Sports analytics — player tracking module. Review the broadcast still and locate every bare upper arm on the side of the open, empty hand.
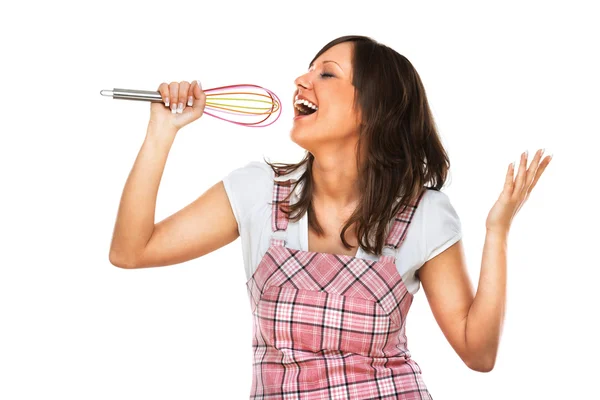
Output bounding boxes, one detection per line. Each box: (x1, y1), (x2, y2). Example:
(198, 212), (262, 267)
(417, 240), (475, 365)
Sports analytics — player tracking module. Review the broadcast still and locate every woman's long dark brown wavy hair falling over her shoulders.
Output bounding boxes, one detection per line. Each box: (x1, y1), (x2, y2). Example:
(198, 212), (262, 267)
(263, 35), (450, 254)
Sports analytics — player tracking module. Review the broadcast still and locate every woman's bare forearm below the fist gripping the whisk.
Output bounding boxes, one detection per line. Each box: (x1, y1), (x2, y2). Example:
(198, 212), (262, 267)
(110, 123), (176, 265)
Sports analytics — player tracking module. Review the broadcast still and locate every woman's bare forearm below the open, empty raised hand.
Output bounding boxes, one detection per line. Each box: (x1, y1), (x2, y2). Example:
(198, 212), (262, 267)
(465, 230), (508, 370)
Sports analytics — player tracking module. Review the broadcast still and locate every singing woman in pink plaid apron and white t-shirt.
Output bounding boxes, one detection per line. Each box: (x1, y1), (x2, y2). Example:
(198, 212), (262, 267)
(110, 36), (550, 399)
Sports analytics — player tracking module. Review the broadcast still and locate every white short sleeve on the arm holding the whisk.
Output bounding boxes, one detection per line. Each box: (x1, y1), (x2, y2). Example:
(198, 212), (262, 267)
(223, 161), (274, 234)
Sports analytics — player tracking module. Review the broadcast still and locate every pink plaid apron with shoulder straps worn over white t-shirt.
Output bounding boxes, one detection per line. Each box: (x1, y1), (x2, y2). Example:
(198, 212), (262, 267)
(246, 180), (432, 400)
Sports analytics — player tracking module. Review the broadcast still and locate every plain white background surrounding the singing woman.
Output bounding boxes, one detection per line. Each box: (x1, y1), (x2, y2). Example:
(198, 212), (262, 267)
(0, 0), (600, 400)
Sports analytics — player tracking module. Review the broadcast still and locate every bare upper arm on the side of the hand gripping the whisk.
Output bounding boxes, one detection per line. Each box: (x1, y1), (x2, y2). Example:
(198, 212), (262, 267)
(129, 181), (239, 268)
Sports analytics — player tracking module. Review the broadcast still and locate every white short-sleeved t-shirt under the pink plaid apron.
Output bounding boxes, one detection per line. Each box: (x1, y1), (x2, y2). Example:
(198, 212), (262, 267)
(223, 161), (462, 295)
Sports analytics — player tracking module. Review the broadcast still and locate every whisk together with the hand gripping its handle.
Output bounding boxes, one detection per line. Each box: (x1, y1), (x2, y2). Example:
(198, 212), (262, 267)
(100, 81), (281, 129)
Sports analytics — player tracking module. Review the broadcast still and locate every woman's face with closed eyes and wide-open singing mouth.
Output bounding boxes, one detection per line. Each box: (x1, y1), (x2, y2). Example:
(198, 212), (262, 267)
(290, 42), (360, 153)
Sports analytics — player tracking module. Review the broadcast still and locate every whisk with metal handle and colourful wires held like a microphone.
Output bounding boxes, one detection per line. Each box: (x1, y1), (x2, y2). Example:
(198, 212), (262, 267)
(100, 84), (281, 128)
